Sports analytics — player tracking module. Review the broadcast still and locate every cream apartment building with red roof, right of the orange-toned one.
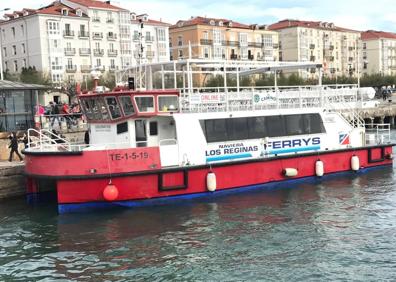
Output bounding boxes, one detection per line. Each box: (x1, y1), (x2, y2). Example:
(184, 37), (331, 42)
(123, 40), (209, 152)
(269, 19), (362, 77)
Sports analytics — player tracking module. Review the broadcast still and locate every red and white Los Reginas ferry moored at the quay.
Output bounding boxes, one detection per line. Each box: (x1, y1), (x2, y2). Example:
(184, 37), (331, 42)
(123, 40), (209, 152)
(24, 59), (393, 213)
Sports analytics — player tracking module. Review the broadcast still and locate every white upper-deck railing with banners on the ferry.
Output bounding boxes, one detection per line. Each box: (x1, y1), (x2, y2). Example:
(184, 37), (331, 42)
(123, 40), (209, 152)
(180, 85), (358, 113)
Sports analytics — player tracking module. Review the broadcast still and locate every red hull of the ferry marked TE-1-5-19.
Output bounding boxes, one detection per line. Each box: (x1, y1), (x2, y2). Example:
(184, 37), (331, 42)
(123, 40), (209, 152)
(26, 145), (392, 207)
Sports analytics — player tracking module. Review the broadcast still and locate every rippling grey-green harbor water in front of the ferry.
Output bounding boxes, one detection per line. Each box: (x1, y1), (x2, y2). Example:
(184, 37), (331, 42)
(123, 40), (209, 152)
(0, 136), (396, 281)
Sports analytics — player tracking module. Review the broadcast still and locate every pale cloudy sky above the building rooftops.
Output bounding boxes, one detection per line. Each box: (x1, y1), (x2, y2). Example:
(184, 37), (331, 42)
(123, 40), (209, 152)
(0, 0), (396, 32)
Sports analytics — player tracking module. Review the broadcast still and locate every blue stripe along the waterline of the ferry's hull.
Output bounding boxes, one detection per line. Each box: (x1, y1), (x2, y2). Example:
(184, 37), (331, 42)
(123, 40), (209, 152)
(58, 164), (392, 214)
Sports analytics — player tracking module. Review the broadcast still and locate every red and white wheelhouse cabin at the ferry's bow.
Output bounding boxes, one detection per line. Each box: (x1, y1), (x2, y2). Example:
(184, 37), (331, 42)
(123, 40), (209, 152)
(78, 90), (179, 149)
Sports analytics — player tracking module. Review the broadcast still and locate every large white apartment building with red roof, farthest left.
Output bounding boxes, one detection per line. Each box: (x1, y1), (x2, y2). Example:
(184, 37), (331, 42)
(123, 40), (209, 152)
(0, 0), (169, 84)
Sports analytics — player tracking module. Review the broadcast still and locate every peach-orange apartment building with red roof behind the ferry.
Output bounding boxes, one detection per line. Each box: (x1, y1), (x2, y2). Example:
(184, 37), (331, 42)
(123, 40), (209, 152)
(169, 17), (278, 61)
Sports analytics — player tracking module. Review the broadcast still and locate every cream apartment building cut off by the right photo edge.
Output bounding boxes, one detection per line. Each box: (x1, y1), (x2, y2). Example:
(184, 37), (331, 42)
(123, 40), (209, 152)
(362, 30), (396, 75)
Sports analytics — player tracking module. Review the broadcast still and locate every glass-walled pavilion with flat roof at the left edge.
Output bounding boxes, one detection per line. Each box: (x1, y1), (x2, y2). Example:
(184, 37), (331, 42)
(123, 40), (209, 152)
(0, 80), (49, 132)
